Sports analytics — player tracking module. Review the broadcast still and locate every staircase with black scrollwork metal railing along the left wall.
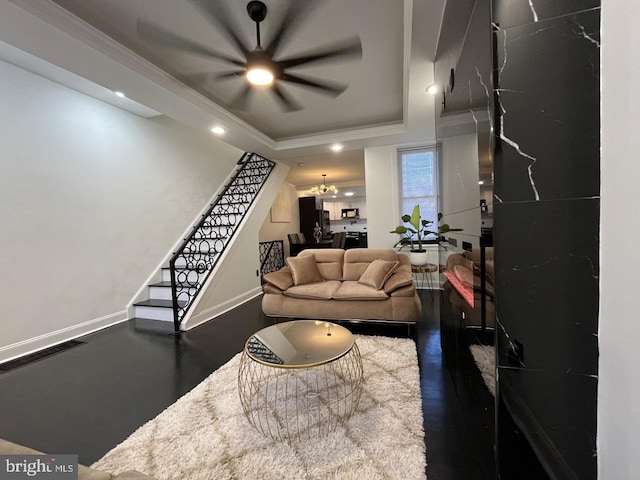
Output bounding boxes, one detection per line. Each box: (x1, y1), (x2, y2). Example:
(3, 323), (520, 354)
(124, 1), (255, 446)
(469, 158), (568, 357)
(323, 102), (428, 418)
(134, 153), (275, 332)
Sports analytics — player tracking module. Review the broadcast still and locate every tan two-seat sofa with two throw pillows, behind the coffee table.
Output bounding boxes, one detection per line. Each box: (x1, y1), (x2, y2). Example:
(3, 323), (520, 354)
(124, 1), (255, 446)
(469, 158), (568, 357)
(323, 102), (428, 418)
(262, 248), (421, 324)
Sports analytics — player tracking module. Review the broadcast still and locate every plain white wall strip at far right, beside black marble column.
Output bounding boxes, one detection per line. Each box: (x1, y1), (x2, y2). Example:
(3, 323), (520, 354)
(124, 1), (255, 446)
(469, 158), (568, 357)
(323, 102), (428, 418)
(598, 0), (640, 480)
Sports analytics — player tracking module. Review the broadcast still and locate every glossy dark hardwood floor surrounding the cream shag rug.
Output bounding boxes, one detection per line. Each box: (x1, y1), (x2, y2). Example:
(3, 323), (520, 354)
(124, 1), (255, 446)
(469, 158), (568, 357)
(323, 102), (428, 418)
(0, 291), (483, 480)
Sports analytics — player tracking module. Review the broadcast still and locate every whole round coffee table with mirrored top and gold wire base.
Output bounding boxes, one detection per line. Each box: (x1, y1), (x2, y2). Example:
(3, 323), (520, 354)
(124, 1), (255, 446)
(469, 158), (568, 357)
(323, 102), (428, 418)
(238, 320), (362, 440)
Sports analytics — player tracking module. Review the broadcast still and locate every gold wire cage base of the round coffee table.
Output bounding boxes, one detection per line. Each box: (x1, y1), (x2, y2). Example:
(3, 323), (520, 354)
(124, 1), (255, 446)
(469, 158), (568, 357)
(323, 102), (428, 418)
(238, 342), (363, 441)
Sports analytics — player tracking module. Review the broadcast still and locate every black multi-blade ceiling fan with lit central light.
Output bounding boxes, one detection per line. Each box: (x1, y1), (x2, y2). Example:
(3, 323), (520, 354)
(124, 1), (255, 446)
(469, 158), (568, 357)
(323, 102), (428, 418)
(137, 0), (362, 111)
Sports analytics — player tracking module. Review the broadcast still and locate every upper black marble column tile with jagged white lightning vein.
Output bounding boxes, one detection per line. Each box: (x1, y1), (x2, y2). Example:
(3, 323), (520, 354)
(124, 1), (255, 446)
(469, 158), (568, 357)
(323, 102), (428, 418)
(495, 10), (600, 202)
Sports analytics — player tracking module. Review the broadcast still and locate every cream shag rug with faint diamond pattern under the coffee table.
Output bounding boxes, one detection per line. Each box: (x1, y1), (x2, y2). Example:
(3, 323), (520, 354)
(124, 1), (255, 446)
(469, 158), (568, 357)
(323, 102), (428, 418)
(92, 335), (426, 480)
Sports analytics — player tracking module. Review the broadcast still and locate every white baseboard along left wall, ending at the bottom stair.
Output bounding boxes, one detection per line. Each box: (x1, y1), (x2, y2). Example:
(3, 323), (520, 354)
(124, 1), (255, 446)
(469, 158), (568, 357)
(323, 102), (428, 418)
(0, 310), (127, 363)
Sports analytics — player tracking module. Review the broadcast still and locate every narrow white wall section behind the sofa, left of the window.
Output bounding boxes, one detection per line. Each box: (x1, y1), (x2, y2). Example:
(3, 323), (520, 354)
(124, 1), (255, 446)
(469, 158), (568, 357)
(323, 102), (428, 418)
(364, 145), (400, 248)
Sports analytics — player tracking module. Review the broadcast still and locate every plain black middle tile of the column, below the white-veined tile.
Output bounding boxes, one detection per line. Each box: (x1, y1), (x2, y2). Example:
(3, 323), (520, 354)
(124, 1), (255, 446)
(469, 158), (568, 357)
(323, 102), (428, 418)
(494, 199), (600, 374)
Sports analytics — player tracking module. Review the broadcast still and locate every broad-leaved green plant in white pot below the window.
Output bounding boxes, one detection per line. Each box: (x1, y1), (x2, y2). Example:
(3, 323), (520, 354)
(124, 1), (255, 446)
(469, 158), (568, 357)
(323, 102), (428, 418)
(390, 205), (462, 265)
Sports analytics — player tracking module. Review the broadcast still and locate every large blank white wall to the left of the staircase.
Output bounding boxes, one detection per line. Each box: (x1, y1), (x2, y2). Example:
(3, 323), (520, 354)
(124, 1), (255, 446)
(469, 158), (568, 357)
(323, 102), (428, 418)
(0, 62), (242, 360)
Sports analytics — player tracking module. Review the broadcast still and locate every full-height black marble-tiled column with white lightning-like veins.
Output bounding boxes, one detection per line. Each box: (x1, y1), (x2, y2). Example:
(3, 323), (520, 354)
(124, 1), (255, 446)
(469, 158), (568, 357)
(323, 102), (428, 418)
(493, 0), (600, 479)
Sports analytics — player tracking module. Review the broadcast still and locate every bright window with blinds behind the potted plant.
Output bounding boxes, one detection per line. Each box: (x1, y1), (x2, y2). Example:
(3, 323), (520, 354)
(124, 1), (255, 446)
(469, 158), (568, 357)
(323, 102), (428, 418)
(398, 143), (438, 239)
